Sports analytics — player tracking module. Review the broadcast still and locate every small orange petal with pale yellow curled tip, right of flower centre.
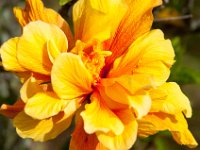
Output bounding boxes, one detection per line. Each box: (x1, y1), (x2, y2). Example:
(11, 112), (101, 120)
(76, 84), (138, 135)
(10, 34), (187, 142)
(101, 76), (151, 118)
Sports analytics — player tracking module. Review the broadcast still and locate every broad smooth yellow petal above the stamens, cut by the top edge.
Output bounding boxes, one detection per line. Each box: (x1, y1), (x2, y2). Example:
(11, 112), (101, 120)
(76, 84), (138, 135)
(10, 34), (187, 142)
(73, 0), (127, 43)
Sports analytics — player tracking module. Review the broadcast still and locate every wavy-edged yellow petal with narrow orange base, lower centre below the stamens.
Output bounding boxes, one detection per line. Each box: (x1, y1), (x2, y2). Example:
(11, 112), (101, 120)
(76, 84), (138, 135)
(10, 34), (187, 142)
(81, 93), (124, 135)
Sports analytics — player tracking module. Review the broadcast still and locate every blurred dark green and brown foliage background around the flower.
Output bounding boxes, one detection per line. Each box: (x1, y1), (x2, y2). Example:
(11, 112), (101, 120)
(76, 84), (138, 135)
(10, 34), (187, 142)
(0, 0), (200, 150)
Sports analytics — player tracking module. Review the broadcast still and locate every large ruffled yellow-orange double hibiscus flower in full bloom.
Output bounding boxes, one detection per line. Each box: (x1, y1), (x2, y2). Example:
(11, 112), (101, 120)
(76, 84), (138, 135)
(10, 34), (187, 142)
(0, 0), (197, 150)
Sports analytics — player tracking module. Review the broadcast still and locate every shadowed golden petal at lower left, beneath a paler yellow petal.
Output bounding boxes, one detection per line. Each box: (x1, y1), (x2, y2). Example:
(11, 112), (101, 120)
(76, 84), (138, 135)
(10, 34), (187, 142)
(14, 111), (72, 142)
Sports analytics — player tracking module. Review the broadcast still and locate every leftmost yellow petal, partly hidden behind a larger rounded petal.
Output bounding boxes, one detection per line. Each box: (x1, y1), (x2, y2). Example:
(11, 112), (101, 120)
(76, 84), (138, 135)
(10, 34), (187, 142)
(0, 37), (26, 72)
